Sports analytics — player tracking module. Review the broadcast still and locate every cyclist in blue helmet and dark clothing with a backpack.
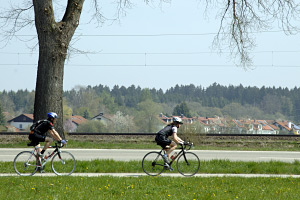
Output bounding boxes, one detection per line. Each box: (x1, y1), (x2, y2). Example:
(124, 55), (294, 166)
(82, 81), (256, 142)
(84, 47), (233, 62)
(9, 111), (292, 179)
(28, 112), (66, 159)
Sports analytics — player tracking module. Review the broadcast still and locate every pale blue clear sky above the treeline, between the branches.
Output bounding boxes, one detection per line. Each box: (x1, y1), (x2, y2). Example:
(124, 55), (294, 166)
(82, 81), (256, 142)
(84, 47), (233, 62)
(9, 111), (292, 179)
(0, 0), (300, 91)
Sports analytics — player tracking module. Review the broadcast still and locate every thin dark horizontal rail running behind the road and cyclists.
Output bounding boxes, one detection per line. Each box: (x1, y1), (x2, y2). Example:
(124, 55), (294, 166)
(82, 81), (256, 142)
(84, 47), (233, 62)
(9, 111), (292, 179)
(0, 132), (300, 137)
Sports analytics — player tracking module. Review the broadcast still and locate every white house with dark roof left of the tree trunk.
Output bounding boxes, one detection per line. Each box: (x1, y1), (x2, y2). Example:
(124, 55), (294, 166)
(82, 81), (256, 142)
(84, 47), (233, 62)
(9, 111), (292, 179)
(7, 114), (33, 131)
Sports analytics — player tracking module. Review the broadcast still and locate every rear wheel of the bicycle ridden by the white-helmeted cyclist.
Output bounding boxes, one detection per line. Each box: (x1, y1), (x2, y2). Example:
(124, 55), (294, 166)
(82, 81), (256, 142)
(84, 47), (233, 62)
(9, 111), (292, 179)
(142, 151), (165, 176)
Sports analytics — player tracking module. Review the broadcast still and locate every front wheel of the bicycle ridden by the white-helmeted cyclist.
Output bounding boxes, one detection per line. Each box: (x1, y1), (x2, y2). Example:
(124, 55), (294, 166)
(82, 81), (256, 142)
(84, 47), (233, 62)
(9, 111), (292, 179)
(177, 152), (200, 176)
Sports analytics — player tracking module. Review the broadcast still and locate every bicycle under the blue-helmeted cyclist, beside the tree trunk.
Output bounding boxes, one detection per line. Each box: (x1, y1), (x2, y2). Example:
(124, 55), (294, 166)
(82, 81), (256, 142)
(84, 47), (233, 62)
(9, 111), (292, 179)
(14, 143), (76, 176)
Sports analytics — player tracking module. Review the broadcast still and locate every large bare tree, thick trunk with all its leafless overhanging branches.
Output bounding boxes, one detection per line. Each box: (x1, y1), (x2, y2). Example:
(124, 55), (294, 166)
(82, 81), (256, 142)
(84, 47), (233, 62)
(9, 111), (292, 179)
(0, 0), (300, 136)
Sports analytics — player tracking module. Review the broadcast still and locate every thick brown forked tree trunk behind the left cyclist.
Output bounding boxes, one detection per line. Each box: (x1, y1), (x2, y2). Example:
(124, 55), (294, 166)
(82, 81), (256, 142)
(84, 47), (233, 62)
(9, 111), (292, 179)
(33, 0), (84, 138)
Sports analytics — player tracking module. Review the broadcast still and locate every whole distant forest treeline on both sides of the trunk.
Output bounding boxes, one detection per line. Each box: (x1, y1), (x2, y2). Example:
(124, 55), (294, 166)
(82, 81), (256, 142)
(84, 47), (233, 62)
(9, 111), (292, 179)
(0, 83), (300, 123)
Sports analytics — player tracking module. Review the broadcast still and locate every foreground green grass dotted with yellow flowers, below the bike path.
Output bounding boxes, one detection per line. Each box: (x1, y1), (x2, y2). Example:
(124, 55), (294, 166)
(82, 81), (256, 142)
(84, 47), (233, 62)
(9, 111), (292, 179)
(0, 176), (300, 200)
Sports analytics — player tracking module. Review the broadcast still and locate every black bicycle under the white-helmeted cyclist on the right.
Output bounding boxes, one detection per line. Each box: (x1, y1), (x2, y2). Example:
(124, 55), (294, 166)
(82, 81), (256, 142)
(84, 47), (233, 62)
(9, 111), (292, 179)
(142, 143), (200, 176)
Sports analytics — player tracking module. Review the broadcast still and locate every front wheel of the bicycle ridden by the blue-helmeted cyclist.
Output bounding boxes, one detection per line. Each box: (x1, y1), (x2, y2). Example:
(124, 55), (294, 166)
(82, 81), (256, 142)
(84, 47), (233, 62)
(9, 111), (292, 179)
(51, 151), (76, 176)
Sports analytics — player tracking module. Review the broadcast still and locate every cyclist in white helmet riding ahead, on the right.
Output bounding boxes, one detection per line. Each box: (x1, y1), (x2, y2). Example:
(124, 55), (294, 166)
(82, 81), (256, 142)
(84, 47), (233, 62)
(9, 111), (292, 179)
(155, 117), (184, 168)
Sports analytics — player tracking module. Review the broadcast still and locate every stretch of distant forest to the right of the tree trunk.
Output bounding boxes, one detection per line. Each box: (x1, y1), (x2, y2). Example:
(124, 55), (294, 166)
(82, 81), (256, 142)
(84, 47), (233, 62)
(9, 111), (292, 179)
(64, 83), (300, 121)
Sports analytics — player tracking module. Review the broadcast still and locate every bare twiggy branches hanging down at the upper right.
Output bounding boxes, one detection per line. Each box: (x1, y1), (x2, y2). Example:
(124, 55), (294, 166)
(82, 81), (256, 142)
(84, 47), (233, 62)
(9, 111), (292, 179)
(210, 0), (300, 69)
